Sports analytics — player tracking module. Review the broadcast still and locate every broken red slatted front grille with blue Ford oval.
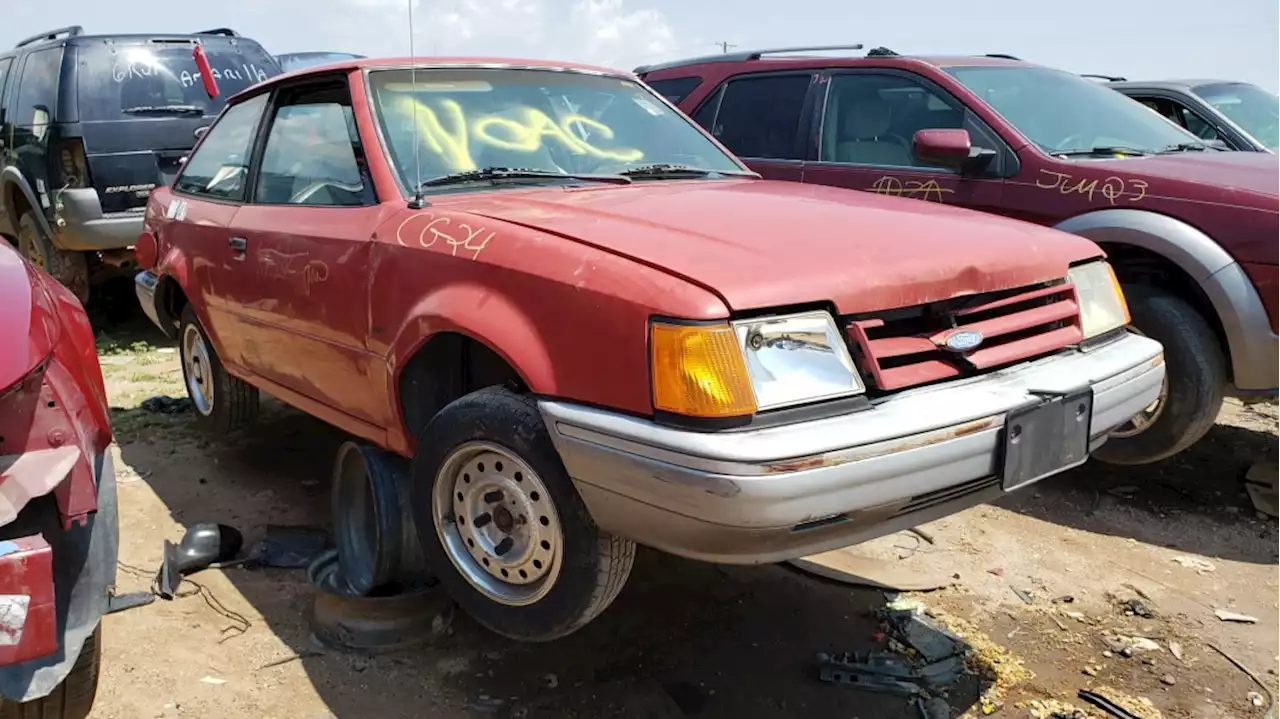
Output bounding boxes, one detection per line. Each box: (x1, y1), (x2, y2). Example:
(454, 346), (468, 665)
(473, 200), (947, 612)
(846, 281), (1084, 391)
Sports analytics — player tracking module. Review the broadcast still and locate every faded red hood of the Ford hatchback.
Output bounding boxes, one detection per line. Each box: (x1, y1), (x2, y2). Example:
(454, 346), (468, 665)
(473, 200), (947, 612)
(466, 180), (1102, 313)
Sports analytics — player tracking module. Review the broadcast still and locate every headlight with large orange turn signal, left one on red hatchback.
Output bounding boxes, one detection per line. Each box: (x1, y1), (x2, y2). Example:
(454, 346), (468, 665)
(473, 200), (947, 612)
(652, 312), (865, 417)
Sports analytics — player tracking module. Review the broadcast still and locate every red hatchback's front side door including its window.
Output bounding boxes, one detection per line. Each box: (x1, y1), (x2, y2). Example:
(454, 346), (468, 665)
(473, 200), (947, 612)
(229, 75), (389, 423)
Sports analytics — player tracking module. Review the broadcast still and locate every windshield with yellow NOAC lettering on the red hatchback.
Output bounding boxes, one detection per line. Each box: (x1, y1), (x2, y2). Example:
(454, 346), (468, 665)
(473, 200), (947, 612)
(369, 68), (746, 192)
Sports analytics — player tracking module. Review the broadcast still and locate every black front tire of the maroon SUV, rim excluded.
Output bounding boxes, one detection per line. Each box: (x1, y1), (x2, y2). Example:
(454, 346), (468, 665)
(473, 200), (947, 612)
(1094, 285), (1226, 464)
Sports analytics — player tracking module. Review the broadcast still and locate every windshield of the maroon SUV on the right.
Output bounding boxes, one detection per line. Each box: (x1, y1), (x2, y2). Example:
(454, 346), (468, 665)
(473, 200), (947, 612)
(947, 65), (1202, 154)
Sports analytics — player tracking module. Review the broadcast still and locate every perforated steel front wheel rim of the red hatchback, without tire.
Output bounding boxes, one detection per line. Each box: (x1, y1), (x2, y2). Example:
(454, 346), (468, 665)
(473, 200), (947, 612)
(431, 441), (564, 606)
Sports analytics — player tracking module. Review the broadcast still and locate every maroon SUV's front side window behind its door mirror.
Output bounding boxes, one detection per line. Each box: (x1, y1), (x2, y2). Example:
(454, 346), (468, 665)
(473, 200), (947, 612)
(819, 74), (962, 169)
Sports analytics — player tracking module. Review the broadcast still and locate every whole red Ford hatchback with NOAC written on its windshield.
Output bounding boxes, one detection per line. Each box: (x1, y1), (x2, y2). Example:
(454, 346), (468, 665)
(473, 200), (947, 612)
(137, 59), (1164, 640)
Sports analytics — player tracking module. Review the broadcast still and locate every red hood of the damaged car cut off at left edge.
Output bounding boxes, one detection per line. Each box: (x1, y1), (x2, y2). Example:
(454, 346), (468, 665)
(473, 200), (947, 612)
(0, 243), (58, 393)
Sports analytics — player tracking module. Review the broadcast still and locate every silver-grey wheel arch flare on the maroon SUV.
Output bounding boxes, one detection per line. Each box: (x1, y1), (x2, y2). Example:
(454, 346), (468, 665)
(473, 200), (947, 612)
(1055, 209), (1280, 391)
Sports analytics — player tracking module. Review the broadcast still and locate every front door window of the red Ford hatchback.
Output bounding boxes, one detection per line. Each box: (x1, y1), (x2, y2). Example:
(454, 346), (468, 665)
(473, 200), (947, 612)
(253, 81), (371, 207)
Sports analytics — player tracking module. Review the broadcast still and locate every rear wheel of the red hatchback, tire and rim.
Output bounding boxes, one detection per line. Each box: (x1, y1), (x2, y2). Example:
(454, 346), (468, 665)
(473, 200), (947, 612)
(178, 304), (259, 434)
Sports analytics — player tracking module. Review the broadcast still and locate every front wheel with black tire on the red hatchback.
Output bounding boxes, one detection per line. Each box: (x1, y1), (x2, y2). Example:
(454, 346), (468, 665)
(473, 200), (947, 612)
(413, 388), (635, 641)
